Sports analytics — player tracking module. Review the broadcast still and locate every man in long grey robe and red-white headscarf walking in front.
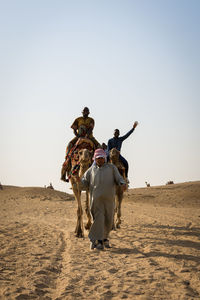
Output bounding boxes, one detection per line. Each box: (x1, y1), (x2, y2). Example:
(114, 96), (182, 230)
(81, 149), (126, 250)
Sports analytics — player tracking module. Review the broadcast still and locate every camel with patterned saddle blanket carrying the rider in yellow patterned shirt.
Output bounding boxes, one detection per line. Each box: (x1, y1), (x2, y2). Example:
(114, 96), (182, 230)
(69, 138), (94, 238)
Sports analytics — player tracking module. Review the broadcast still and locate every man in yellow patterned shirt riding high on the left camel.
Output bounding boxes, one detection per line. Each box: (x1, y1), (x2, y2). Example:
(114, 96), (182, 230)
(61, 107), (100, 182)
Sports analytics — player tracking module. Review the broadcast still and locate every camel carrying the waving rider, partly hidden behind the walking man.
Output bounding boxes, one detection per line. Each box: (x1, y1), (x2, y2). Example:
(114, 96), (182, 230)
(109, 148), (128, 229)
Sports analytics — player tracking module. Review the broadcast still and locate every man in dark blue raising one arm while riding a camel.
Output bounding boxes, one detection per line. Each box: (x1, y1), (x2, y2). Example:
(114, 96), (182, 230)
(108, 121), (138, 181)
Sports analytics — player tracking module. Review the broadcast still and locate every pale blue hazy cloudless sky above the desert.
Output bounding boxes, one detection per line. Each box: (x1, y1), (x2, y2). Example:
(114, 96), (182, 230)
(0, 0), (200, 193)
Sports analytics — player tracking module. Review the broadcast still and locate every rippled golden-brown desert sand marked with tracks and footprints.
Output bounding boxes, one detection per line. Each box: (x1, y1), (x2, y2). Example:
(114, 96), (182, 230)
(0, 181), (200, 300)
